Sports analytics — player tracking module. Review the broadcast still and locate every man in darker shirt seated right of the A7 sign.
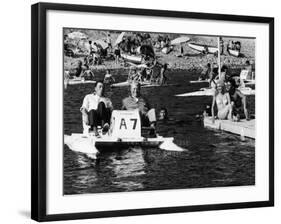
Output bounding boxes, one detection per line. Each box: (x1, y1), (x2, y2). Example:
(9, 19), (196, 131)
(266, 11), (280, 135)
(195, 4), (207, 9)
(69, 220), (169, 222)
(122, 82), (156, 137)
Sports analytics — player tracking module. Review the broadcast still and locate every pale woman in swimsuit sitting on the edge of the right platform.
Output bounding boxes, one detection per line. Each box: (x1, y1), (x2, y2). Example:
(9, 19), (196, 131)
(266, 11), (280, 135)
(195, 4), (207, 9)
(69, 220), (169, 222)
(211, 82), (232, 123)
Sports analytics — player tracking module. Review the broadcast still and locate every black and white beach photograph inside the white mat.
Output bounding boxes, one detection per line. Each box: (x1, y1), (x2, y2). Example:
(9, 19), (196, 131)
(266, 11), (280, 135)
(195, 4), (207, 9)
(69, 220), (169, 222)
(62, 27), (256, 195)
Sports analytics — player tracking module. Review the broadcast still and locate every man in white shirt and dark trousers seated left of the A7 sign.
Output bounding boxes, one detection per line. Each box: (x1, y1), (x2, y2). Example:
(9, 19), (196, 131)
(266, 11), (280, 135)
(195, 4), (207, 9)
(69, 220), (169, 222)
(80, 81), (113, 137)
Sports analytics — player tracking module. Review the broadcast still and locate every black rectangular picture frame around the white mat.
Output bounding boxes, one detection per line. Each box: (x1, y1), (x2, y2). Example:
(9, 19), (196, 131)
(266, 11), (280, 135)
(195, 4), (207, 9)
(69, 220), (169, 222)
(31, 3), (274, 221)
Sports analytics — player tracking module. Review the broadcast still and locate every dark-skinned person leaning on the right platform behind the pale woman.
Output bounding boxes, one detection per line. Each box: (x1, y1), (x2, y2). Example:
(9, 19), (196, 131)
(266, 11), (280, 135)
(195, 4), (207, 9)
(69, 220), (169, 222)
(225, 79), (249, 121)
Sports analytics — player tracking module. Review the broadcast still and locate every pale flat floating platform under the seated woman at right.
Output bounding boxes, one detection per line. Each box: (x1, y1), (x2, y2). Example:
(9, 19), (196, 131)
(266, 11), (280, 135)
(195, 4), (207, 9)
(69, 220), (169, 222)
(204, 117), (256, 139)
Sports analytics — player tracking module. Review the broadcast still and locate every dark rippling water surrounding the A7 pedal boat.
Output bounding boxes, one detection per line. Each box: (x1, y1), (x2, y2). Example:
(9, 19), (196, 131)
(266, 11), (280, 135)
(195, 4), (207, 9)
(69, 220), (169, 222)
(64, 70), (255, 194)
